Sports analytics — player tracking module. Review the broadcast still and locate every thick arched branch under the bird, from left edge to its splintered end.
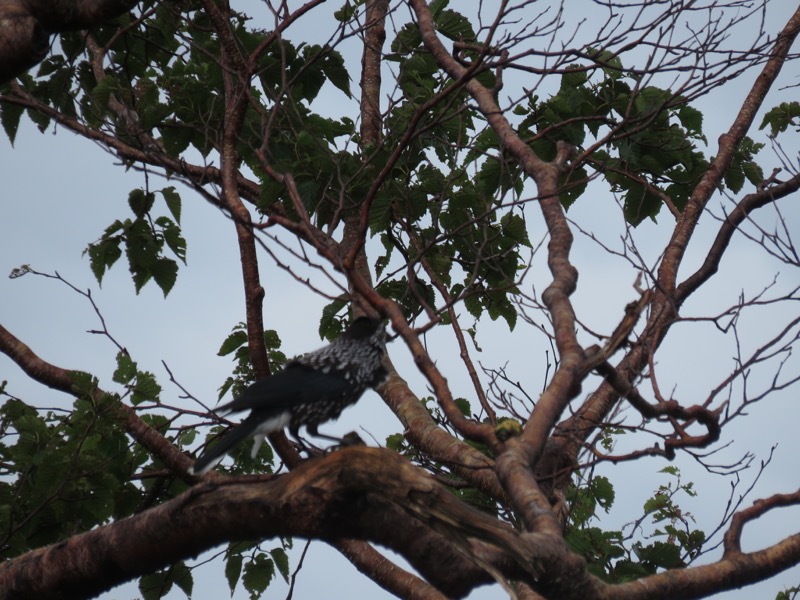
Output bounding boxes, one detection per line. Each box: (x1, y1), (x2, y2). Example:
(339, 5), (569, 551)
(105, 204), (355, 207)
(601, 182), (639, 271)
(0, 447), (531, 599)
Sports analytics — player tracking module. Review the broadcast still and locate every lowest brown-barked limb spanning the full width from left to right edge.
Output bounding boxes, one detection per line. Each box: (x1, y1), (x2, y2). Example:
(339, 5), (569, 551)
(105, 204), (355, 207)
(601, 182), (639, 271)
(0, 447), (800, 600)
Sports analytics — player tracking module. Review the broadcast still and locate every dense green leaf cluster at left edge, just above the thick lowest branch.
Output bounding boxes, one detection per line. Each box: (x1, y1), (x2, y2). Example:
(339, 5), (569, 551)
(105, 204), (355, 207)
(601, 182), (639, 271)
(0, 392), (141, 558)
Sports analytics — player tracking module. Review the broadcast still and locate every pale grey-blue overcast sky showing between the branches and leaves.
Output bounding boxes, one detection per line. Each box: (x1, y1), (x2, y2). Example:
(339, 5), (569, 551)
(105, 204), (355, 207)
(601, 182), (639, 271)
(0, 2), (800, 600)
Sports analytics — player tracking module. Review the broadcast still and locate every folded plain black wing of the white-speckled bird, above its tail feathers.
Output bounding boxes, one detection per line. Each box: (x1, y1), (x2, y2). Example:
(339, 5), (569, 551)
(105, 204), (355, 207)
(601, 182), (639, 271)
(215, 363), (351, 413)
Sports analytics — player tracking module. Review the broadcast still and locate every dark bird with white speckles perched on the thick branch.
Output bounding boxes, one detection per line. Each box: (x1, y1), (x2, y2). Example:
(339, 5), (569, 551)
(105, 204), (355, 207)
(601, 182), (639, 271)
(189, 316), (389, 475)
